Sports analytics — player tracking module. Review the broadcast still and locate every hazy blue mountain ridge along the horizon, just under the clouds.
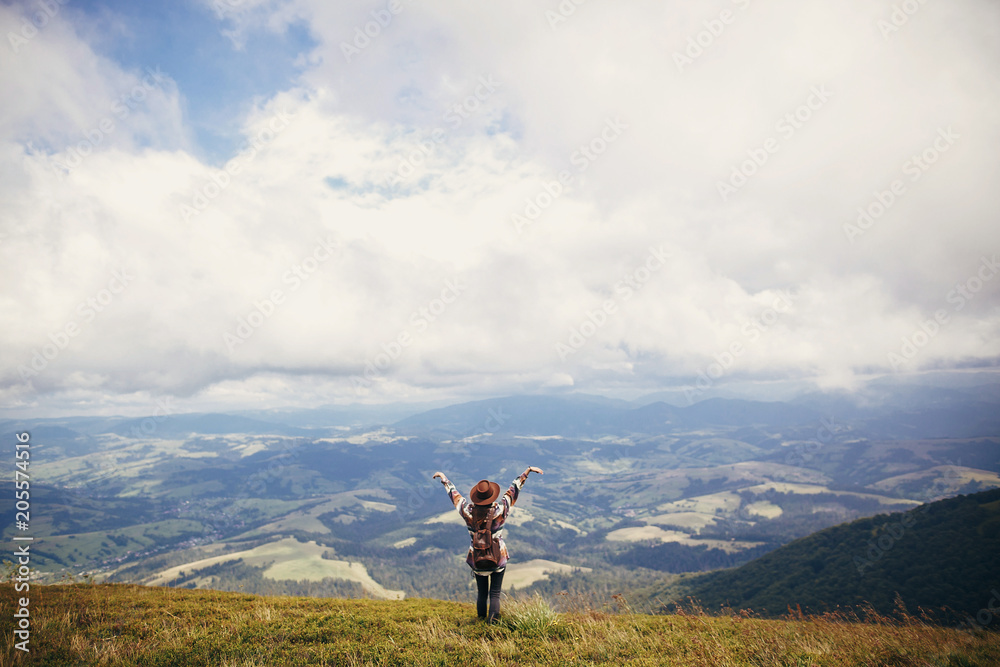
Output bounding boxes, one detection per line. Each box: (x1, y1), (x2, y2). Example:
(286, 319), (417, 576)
(7, 382), (1000, 440)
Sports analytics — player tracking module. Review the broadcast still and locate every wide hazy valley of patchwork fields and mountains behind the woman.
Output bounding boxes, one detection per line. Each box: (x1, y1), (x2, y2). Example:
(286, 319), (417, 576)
(0, 382), (1000, 624)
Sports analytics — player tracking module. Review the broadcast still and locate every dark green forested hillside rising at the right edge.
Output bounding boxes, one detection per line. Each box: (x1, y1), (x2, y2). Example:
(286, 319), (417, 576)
(672, 489), (1000, 624)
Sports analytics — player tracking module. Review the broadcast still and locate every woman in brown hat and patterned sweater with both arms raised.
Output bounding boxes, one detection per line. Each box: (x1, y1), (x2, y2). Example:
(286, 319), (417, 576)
(433, 466), (543, 624)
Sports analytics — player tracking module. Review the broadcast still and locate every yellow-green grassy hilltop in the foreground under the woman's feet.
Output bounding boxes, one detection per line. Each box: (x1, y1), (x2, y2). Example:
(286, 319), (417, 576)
(0, 584), (1000, 667)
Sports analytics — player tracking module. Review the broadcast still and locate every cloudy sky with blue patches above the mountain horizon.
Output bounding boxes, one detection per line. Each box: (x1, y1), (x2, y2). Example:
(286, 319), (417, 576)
(0, 0), (1000, 416)
